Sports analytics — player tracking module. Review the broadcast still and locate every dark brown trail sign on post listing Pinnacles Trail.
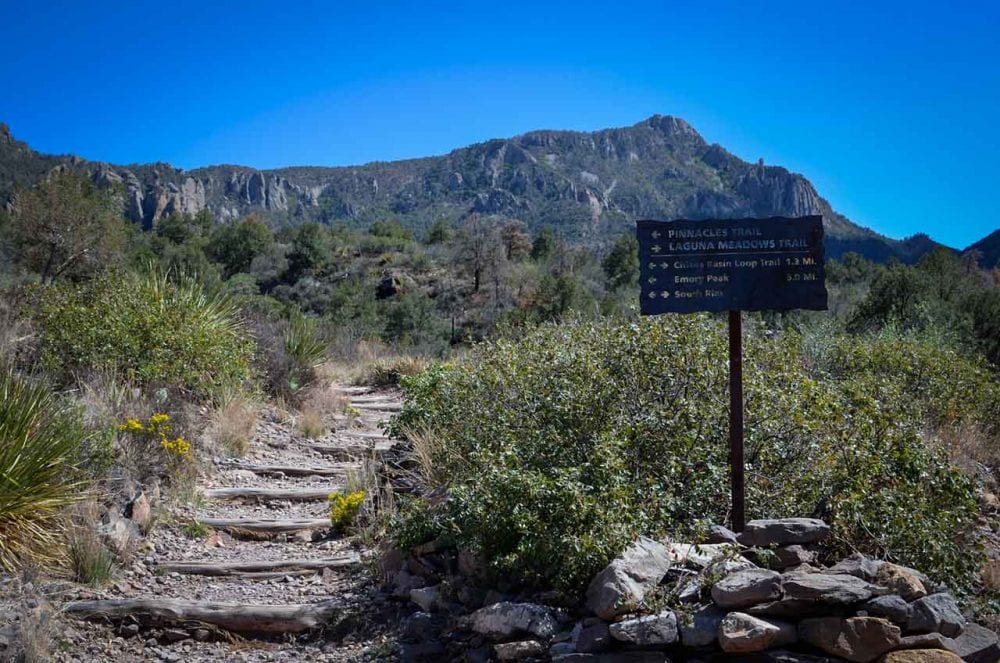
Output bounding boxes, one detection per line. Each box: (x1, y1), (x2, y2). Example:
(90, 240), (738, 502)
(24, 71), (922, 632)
(636, 216), (827, 531)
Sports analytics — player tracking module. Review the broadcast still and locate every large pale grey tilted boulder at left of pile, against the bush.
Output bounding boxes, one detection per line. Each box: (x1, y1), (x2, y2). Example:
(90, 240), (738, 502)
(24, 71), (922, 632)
(587, 537), (672, 619)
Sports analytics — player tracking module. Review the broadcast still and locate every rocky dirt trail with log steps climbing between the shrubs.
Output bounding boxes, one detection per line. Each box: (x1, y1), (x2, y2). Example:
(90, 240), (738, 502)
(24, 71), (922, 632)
(56, 386), (401, 663)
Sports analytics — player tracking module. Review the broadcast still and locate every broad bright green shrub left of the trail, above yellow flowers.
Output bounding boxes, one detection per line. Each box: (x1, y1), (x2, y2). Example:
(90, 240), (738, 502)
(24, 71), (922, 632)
(37, 272), (253, 398)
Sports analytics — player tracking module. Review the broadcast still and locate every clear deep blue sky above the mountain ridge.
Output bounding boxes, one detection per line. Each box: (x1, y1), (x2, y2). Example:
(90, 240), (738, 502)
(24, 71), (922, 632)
(0, 0), (1000, 247)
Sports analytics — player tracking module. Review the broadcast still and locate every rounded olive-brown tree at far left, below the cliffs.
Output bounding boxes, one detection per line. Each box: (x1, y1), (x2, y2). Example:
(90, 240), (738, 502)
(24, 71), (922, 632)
(10, 170), (127, 283)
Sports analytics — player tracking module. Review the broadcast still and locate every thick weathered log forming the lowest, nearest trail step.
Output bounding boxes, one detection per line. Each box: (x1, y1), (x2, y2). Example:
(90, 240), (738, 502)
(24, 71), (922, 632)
(62, 599), (341, 635)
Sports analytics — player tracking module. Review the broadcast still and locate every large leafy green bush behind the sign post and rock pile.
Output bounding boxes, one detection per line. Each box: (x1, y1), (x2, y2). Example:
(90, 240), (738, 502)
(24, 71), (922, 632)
(393, 316), (985, 590)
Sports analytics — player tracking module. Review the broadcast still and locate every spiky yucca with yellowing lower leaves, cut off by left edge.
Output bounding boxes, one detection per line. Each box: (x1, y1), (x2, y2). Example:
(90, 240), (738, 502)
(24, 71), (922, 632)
(0, 368), (84, 571)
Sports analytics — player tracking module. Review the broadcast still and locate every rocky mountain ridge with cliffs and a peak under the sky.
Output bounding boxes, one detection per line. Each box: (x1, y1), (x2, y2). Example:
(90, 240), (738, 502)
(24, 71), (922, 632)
(0, 115), (939, 262)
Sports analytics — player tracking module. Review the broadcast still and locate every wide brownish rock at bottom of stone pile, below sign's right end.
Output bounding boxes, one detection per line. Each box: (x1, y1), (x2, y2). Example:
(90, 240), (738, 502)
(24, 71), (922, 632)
(799, 617), (900, 663)
